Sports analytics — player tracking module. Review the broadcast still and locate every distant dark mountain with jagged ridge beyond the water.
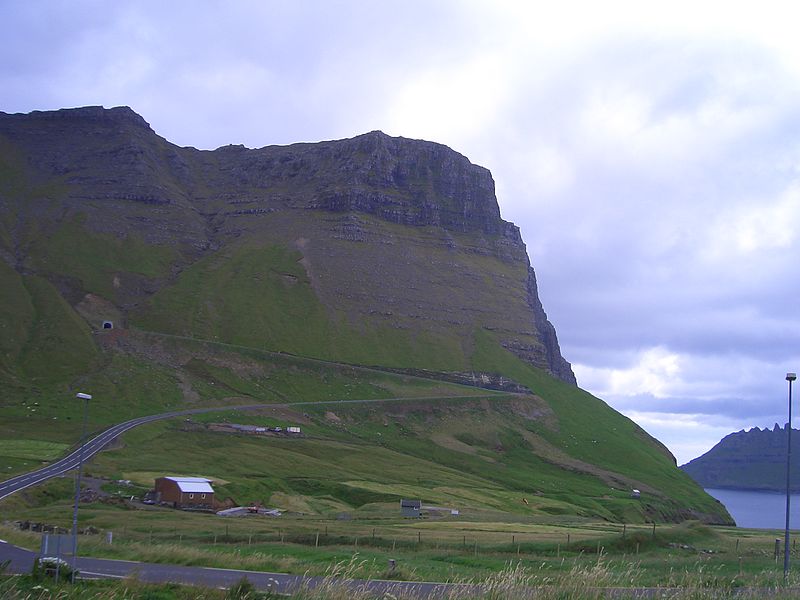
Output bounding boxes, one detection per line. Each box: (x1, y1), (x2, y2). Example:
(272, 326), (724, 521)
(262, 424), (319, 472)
(681, 423), (800, 492)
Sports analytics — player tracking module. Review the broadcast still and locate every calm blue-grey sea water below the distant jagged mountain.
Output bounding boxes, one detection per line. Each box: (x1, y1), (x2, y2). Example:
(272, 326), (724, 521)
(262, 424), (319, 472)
(706, 488), (800, 531)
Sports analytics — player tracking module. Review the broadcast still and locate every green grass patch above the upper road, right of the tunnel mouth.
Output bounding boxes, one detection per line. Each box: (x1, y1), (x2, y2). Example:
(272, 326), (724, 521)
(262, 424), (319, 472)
(132, 238), (476, 370)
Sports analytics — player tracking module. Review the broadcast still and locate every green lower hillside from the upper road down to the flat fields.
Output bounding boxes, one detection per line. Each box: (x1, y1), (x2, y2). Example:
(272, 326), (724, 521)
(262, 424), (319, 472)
(0, 332), (721, 523)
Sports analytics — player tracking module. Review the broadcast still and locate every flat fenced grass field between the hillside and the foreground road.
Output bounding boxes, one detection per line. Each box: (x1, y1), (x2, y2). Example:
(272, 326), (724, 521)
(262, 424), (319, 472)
(0, 505), (800, 598)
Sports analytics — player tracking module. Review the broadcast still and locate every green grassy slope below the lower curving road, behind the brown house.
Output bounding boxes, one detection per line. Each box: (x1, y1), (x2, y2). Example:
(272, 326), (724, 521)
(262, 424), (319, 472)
(70, 384), (717, 523)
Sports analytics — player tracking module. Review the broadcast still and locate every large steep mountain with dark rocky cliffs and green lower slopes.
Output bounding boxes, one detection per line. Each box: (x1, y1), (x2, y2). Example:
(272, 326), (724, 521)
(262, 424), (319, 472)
(0, 107), (731, 523)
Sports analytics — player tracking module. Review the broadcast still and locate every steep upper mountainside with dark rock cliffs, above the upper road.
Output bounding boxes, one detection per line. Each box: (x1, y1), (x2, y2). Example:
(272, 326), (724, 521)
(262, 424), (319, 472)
(0, 107), (575, 384)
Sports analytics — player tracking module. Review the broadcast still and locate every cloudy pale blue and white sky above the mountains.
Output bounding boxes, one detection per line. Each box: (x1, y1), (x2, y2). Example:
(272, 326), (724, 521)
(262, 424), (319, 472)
(0, 0), (800, 464)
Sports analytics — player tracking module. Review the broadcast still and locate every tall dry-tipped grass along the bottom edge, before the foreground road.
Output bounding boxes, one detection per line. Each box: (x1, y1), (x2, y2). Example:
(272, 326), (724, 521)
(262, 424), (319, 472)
(0, 555), (800, 600)
